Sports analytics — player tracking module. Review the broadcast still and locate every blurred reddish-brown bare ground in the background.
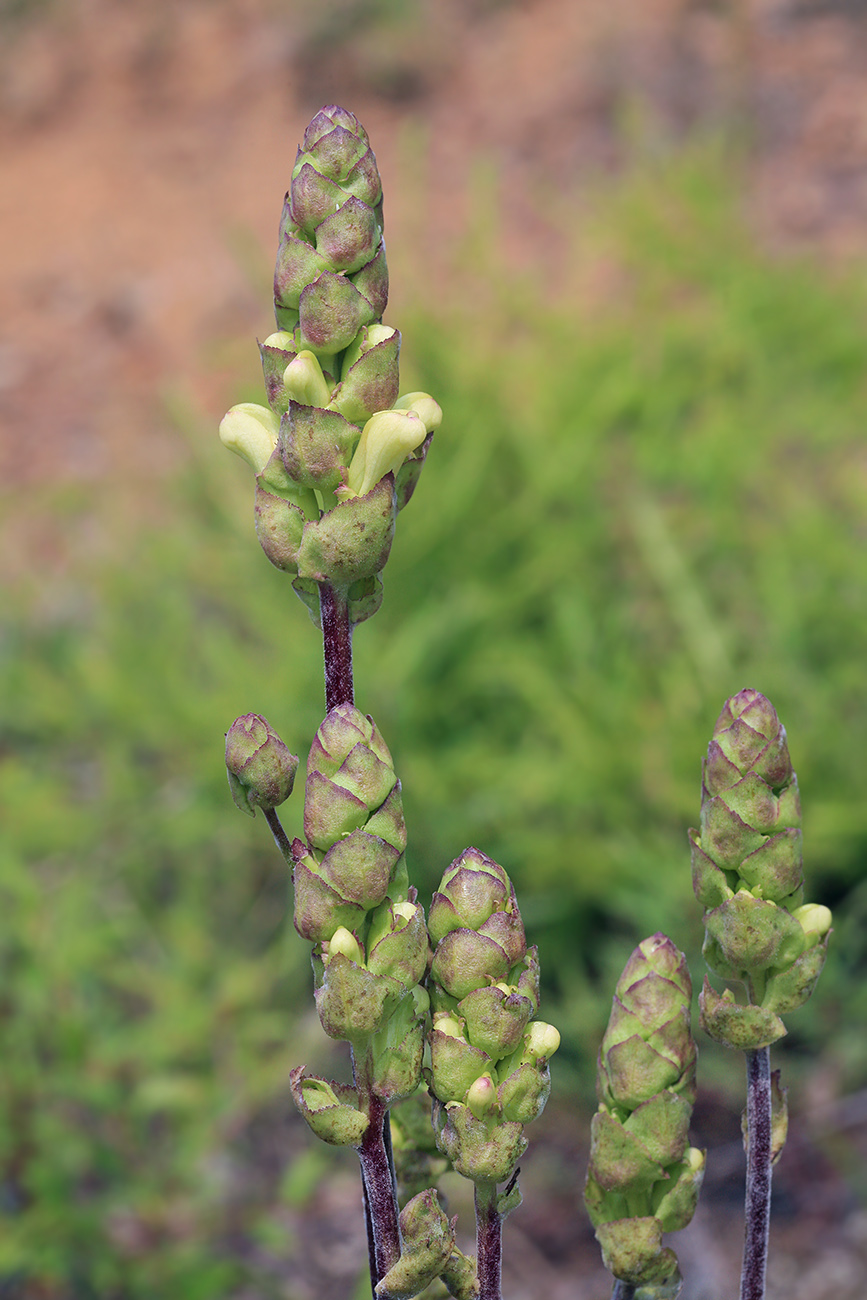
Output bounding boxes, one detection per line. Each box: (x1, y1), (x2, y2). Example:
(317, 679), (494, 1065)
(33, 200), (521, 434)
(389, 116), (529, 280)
(0, 0), (867, 1300)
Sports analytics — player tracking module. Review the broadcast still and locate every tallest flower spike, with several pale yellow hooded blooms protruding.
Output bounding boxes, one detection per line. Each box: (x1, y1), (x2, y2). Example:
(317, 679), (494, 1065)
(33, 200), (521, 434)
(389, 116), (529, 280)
(220, 105), (441, 623)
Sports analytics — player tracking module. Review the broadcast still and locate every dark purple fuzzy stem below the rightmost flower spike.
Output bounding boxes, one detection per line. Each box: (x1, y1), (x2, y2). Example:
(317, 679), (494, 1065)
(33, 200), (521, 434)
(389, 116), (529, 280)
(741, 1048), (771, 1300)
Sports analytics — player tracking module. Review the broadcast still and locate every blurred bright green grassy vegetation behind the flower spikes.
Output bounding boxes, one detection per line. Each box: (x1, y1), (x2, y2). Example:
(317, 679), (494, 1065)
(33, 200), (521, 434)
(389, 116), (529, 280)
(0, 144), (867, 1300)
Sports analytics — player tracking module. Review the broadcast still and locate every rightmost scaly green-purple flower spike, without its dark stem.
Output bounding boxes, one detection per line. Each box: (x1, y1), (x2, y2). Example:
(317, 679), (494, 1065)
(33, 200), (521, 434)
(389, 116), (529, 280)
(690, 689), (831, 1050)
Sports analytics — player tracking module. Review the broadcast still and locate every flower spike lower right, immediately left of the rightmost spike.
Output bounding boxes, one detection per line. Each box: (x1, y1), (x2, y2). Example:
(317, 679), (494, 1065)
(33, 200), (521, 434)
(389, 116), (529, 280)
(585, 933), (705, 1295)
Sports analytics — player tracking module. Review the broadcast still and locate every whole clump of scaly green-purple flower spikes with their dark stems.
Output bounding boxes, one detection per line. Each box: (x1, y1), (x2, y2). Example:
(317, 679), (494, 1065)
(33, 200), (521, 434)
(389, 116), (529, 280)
(220, 105), (831, 1300)
